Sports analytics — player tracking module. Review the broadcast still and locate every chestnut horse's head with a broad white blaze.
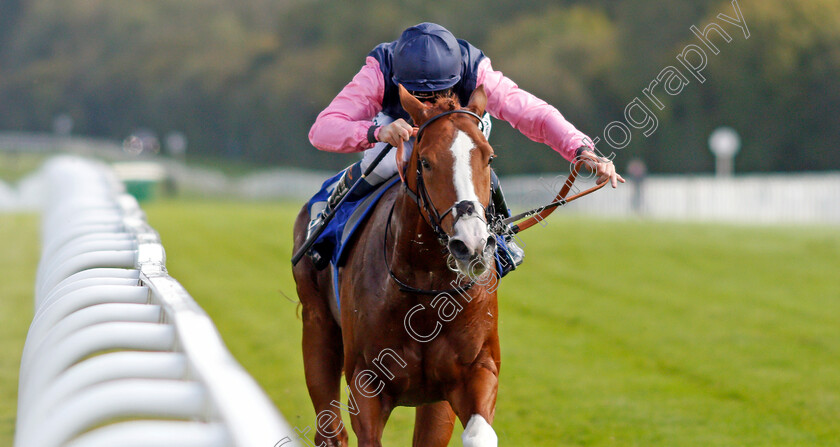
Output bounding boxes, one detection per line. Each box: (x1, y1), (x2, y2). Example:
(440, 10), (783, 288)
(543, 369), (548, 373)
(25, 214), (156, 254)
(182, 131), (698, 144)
(396, 86), (496, 277)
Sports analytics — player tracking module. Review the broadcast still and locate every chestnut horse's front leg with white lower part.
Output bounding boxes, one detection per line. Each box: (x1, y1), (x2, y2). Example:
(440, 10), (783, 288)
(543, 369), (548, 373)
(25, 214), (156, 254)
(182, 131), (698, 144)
(449, 357), (499, 447)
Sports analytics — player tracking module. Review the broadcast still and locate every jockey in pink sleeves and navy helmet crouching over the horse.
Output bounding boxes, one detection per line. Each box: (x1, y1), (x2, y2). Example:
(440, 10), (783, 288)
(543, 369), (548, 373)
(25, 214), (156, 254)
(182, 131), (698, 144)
(307, 23), (624, 265)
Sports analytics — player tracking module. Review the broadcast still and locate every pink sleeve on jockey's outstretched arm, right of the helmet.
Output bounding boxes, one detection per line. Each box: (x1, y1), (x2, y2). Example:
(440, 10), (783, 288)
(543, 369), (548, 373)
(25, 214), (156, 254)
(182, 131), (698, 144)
(478, 58), (592, 161)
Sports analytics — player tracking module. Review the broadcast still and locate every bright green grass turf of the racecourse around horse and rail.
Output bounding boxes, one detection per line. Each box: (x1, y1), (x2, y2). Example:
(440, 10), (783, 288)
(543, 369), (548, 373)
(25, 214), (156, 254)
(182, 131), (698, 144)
(0, 201), (840, 447)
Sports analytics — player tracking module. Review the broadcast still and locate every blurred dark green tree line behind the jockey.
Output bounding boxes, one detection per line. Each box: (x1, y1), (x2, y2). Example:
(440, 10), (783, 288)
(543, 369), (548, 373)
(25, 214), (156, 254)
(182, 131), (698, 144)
(0, 0), (840, 174)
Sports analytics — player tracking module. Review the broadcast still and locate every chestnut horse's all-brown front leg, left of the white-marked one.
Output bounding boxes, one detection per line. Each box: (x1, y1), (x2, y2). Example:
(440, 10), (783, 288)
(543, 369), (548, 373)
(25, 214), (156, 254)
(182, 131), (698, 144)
(346, 369), (394, 447)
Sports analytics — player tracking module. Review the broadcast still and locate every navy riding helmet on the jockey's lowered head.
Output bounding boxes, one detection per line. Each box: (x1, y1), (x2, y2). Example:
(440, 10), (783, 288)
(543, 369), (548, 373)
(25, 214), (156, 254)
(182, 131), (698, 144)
(393, 23), (462, 92)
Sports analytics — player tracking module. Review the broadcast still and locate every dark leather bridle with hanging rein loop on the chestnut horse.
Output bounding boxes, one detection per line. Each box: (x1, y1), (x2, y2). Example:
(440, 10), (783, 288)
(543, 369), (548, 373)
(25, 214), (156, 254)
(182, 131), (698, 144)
(382, 109), (487, 295)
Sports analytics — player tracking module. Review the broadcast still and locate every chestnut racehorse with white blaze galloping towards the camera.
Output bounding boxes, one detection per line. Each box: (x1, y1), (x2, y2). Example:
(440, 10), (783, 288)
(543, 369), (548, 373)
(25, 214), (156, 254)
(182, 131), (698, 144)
(293, 86), (500, 447)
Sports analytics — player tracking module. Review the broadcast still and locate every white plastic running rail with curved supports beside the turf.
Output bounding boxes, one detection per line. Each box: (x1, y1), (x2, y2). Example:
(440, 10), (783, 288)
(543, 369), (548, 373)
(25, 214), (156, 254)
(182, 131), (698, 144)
(15, 157), (298, 447)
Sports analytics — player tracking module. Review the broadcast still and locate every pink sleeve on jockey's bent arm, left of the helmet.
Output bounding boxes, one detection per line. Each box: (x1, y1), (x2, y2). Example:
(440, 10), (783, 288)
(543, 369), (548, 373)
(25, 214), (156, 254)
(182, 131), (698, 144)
(309, 57), (385, 153)
